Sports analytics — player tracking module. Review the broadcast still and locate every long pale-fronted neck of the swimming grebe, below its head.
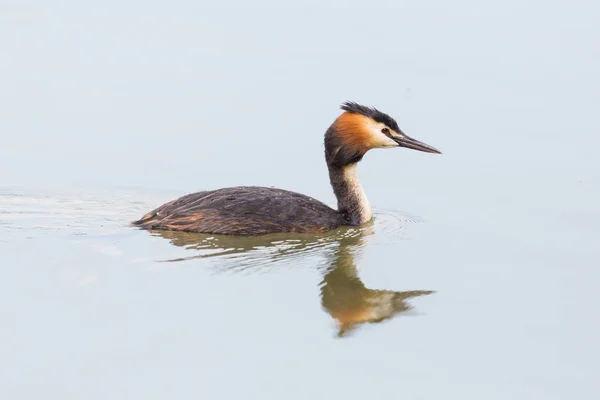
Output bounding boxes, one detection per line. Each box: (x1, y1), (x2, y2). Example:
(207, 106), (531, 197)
(328, 163), (373, 225)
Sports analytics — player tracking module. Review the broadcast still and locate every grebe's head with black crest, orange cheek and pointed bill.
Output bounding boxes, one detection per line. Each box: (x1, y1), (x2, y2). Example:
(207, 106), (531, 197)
(325, 102), (441, 166)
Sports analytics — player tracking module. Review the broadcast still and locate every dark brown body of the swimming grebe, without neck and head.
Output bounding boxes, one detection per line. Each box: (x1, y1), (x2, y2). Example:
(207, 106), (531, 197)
(133, 186), (344, 235)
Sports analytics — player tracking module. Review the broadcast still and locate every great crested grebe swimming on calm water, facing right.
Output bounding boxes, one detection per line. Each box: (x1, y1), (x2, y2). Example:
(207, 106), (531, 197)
(132, 102), (441, 235)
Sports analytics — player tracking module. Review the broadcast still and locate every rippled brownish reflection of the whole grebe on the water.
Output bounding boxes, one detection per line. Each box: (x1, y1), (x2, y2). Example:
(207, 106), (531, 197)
(151, 226), (434, 337)
